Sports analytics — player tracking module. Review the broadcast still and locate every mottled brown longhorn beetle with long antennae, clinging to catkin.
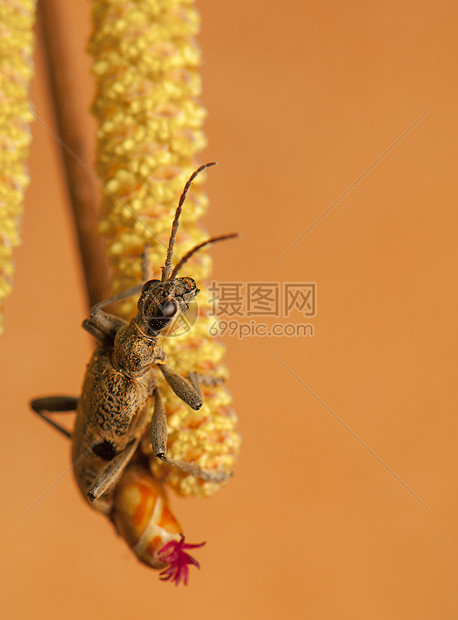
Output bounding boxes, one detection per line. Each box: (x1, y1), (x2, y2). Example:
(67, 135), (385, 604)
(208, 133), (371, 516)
(31, 162), (237, 515)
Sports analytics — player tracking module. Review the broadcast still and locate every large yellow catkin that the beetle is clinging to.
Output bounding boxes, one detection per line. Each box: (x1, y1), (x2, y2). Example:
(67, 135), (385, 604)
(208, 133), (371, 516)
(89, 0), (240, 496)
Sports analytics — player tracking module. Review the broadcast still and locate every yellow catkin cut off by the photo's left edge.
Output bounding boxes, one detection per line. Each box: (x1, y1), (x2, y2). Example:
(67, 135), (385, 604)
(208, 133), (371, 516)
(0, 0), (35, 334)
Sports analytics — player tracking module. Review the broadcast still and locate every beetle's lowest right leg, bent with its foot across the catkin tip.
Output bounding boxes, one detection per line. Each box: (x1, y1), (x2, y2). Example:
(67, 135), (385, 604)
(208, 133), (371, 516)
(150, 389), (232, 482)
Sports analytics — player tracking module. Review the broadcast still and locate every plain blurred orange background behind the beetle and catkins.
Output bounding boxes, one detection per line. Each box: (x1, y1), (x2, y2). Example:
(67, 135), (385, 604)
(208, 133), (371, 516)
(0, 0), (458, 620)
